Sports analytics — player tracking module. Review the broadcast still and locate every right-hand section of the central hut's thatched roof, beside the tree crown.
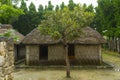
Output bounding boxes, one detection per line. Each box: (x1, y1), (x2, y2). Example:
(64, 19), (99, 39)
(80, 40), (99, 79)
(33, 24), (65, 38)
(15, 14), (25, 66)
(74, 27), (106, 44)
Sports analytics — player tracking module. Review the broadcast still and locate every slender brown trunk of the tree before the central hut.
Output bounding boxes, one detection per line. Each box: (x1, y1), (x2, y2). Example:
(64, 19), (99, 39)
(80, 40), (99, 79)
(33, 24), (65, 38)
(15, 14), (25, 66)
(63, 39), (70, 78)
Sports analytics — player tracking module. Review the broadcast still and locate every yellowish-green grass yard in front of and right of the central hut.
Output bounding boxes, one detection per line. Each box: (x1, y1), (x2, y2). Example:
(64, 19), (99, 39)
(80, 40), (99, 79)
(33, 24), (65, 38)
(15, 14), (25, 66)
(14, 51), (120, 80)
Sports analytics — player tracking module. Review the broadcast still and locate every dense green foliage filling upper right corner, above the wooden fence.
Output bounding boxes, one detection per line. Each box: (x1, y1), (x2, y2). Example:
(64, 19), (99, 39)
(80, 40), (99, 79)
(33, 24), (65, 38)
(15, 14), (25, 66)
(94, 0), (120, 37)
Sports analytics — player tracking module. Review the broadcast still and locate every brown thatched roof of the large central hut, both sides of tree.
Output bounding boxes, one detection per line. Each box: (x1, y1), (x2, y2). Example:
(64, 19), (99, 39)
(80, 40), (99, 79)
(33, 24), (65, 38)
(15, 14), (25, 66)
(22, 27), (106, 44)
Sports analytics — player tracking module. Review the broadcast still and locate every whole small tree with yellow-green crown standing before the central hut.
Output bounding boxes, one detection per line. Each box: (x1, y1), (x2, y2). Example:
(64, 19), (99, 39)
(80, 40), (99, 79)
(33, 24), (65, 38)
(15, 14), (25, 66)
(39, 5), (94, 77)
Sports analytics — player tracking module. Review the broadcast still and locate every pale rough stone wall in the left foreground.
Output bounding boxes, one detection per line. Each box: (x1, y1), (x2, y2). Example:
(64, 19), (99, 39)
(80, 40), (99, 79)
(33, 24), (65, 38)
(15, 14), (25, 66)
(0, 37), (14, 80)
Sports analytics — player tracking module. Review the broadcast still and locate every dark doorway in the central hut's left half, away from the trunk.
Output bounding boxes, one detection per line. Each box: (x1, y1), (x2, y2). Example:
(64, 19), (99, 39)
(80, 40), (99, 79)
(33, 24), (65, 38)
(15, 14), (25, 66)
(39, 45), (48, 60)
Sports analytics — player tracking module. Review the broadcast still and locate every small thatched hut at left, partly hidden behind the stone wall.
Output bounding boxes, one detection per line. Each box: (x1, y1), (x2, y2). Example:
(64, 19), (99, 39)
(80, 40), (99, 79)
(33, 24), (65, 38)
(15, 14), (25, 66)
(0, 24), (25, 60)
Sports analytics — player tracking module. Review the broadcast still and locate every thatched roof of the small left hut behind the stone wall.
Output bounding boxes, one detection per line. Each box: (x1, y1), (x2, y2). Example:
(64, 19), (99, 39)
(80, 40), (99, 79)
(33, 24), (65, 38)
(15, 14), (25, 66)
(0, 24), (25, 44)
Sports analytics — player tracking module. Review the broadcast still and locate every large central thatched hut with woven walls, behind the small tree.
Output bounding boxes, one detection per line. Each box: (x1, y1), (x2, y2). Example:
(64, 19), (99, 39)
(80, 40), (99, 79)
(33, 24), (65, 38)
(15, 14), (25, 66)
(22, 27), (106, 64)
